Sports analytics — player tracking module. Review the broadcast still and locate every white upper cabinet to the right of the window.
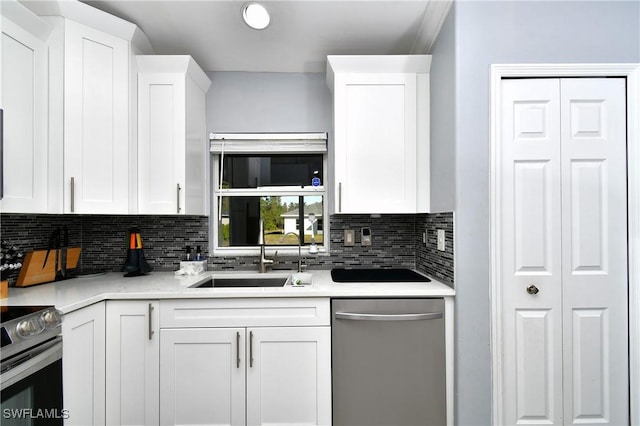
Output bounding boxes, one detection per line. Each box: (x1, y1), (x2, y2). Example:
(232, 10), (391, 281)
(327, 55), (431, 213)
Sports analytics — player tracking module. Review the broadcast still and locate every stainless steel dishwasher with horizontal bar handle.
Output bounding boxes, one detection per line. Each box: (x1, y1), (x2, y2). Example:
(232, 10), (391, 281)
(331, 299), (446, 426)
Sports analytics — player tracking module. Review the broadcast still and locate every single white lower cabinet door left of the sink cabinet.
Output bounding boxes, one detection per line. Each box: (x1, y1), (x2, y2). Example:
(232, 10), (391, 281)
(106, 300), (160, 425)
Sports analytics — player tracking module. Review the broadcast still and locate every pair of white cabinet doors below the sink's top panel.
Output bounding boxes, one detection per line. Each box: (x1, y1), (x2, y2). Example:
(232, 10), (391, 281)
(160, 327), (331, 425)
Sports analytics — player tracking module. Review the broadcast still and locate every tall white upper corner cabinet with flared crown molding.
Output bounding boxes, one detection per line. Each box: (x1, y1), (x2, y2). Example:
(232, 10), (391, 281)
(23, 0), (152, 214)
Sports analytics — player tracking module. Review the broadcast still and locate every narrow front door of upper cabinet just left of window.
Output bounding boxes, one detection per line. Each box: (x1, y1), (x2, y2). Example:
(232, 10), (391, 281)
(138, 73), (186, 214)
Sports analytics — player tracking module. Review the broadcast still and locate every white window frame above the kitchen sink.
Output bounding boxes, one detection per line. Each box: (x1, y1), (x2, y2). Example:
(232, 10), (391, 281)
(209, 133), (330, 257)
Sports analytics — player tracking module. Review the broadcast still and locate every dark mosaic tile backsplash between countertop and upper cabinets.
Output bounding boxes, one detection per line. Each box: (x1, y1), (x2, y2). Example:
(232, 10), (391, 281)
(0, 213), (453, 285)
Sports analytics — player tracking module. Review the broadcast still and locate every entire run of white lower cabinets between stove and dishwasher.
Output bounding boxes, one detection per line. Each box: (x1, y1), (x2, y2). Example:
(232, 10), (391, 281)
(62, 298), (331, 425)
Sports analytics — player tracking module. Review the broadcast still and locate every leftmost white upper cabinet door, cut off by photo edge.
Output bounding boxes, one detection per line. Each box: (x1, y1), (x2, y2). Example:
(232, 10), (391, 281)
(0, 17), (48, 213)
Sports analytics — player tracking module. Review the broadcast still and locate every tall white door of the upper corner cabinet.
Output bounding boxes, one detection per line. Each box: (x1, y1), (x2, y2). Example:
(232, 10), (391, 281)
(64, 20), (129, 213)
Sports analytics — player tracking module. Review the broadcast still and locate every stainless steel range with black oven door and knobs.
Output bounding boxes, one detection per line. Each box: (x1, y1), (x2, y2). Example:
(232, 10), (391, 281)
(0, 306), (68, 426)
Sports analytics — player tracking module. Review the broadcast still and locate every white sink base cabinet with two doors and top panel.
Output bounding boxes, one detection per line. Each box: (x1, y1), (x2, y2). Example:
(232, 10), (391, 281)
(160, 299), (331, 425)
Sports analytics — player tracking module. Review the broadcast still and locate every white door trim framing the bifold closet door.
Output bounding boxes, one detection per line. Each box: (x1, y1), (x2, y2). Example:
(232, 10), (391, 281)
(489, 63), (640, 425)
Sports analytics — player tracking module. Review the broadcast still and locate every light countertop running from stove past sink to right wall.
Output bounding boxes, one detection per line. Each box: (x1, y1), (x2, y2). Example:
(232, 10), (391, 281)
(0, 270), (455, 313)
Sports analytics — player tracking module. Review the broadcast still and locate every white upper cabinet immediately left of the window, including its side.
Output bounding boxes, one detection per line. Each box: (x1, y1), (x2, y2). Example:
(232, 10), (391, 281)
(137, 55), (211, 215)
